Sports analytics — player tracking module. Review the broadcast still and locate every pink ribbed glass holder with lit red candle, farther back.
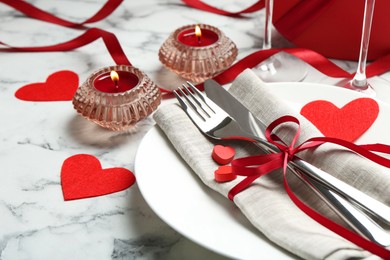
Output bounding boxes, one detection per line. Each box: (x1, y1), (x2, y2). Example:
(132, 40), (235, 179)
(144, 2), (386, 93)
(159, 24), (238, 83)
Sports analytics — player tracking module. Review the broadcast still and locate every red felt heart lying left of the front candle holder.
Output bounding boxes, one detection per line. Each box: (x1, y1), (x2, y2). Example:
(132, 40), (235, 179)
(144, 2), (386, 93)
(15, 70), (79, 101)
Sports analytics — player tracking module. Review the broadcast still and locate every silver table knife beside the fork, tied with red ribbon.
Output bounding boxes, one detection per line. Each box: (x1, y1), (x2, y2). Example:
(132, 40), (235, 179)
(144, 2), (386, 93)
(204, 80), (390, 246)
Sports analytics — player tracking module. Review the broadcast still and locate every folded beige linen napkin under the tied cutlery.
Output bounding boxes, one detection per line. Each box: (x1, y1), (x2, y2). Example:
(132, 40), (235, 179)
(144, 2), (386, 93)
(154, 70), (390, 259)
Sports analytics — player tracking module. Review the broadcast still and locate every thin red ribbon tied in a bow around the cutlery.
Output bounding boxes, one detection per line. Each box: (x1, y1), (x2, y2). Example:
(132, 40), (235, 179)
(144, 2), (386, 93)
(228, 116), (390, 259)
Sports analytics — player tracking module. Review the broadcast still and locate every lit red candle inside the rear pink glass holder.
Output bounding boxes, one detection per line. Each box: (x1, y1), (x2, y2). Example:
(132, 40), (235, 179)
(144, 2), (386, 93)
(177, 25), (219, 47)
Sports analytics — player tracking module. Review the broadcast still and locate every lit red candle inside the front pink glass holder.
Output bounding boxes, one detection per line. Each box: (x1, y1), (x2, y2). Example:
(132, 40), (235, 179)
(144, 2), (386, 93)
(93, 70), (139, 93)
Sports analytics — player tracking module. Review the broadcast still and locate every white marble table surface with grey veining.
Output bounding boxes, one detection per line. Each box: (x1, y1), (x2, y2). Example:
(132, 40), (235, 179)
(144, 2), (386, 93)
(0, 0), (390, 260)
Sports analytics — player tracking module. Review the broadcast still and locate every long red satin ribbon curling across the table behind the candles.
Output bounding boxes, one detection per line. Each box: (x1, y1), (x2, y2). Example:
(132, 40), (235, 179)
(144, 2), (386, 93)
(0, 0), (390, 92)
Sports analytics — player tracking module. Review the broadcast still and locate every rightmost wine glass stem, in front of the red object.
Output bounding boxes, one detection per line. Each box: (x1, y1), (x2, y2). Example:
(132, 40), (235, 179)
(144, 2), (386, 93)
(352, 0), (375, 88)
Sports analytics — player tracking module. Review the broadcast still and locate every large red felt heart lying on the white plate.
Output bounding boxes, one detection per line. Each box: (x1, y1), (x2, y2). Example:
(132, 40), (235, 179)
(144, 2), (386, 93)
(301, 98), (379, 142)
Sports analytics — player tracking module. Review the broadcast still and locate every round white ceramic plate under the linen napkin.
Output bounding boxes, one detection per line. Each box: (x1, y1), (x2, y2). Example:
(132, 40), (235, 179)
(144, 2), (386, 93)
(135, 83), (390, 259)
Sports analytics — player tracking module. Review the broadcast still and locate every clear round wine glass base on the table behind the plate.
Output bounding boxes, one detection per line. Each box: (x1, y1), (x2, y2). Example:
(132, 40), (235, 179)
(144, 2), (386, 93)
(252, 52), (307, 82)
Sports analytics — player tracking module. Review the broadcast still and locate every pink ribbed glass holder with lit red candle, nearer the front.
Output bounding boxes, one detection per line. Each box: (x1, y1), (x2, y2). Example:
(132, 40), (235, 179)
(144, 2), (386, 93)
(73, 65), (161, 131)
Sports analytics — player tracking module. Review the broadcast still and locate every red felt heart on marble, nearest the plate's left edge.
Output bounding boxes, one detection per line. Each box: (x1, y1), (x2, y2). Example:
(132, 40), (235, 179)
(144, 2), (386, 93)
(61, 154), (135, 200)
